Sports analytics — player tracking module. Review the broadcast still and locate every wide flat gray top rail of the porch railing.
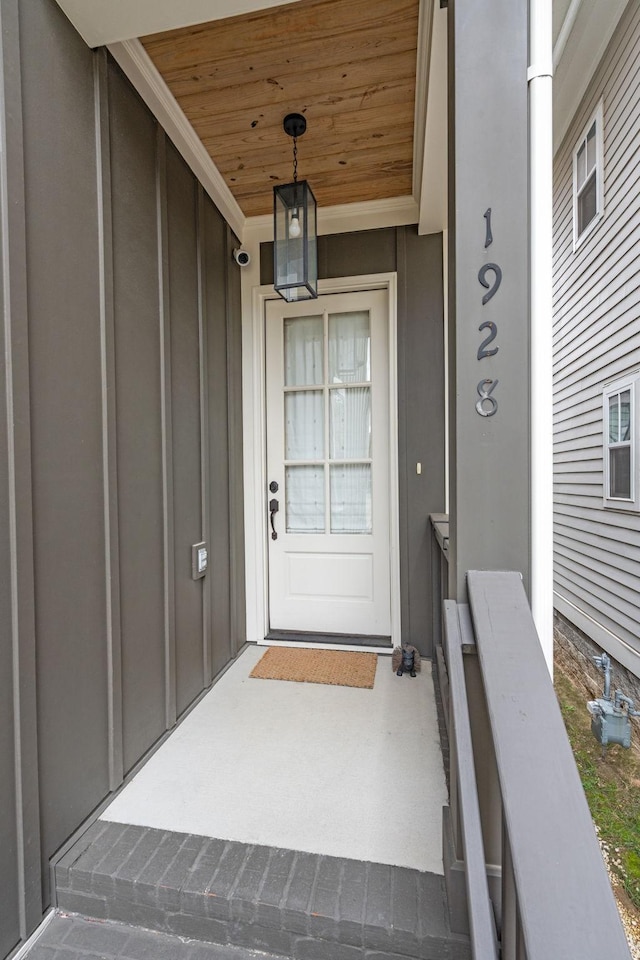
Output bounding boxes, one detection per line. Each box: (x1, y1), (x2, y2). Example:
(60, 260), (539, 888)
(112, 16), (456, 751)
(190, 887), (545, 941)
(464, 571), (630, 960)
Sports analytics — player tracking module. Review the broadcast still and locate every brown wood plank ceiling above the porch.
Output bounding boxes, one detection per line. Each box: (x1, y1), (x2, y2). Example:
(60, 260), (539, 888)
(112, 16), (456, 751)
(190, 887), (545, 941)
(142, 0), (419, 216)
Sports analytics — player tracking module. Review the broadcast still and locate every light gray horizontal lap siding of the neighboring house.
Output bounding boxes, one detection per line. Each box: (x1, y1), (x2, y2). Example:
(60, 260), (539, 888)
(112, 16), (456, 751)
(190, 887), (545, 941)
(554, 2), (640, 676)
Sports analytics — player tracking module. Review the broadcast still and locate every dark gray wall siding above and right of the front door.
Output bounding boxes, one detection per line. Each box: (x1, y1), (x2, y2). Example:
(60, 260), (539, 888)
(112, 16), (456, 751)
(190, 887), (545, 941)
(260, 226), (445, 657)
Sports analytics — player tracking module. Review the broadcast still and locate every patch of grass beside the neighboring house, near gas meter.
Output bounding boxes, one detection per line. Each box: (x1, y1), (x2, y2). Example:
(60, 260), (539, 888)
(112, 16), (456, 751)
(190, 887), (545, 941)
(554, 664), (640, 911)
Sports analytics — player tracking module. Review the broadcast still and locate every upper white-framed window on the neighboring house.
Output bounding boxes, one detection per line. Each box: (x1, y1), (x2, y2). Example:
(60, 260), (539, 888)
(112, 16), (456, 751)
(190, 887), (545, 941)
(573, 104), (604, 245)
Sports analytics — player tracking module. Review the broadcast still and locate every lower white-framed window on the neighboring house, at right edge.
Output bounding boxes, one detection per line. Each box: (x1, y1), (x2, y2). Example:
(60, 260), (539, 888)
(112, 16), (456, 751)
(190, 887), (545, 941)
(603, 374), (640, 510)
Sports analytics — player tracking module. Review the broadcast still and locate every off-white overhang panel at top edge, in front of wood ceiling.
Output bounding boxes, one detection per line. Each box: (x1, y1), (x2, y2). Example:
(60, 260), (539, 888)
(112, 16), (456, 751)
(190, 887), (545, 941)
(53, 0), (308, 47)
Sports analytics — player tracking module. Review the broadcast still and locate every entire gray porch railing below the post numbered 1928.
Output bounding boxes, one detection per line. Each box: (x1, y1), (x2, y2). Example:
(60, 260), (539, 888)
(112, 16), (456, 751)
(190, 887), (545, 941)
(430, 524), (630, 960)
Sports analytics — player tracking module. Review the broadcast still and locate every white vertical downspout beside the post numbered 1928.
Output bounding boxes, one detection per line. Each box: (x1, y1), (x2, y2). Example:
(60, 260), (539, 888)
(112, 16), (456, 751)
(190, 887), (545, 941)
(527, 0), (553, 672)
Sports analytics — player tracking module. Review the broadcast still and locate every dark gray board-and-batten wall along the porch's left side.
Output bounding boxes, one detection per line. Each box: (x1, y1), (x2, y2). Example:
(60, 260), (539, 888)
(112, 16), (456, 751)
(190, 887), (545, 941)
(0, 0), (245, 957)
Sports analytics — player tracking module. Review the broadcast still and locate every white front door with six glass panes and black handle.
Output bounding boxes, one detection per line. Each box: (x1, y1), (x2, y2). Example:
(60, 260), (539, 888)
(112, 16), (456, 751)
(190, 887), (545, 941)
(265, 290), (391, 637)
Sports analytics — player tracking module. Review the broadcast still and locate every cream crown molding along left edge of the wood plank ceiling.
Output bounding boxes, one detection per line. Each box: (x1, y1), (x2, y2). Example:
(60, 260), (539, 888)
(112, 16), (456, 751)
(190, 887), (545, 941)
(108, 40), (246, 239)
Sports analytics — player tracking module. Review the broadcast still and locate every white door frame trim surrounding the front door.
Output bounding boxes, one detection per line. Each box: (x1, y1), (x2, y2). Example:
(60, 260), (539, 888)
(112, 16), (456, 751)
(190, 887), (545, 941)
(242, 273), (401, 653)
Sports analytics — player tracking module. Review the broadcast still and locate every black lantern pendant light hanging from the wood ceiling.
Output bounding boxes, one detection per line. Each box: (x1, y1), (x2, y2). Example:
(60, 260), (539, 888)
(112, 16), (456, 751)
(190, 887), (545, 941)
(273, 113), (318, 302)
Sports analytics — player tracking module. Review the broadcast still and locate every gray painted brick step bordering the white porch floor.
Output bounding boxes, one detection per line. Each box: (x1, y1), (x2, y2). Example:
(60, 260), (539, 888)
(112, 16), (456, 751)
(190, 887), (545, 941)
(56, 821), (470, 960)
